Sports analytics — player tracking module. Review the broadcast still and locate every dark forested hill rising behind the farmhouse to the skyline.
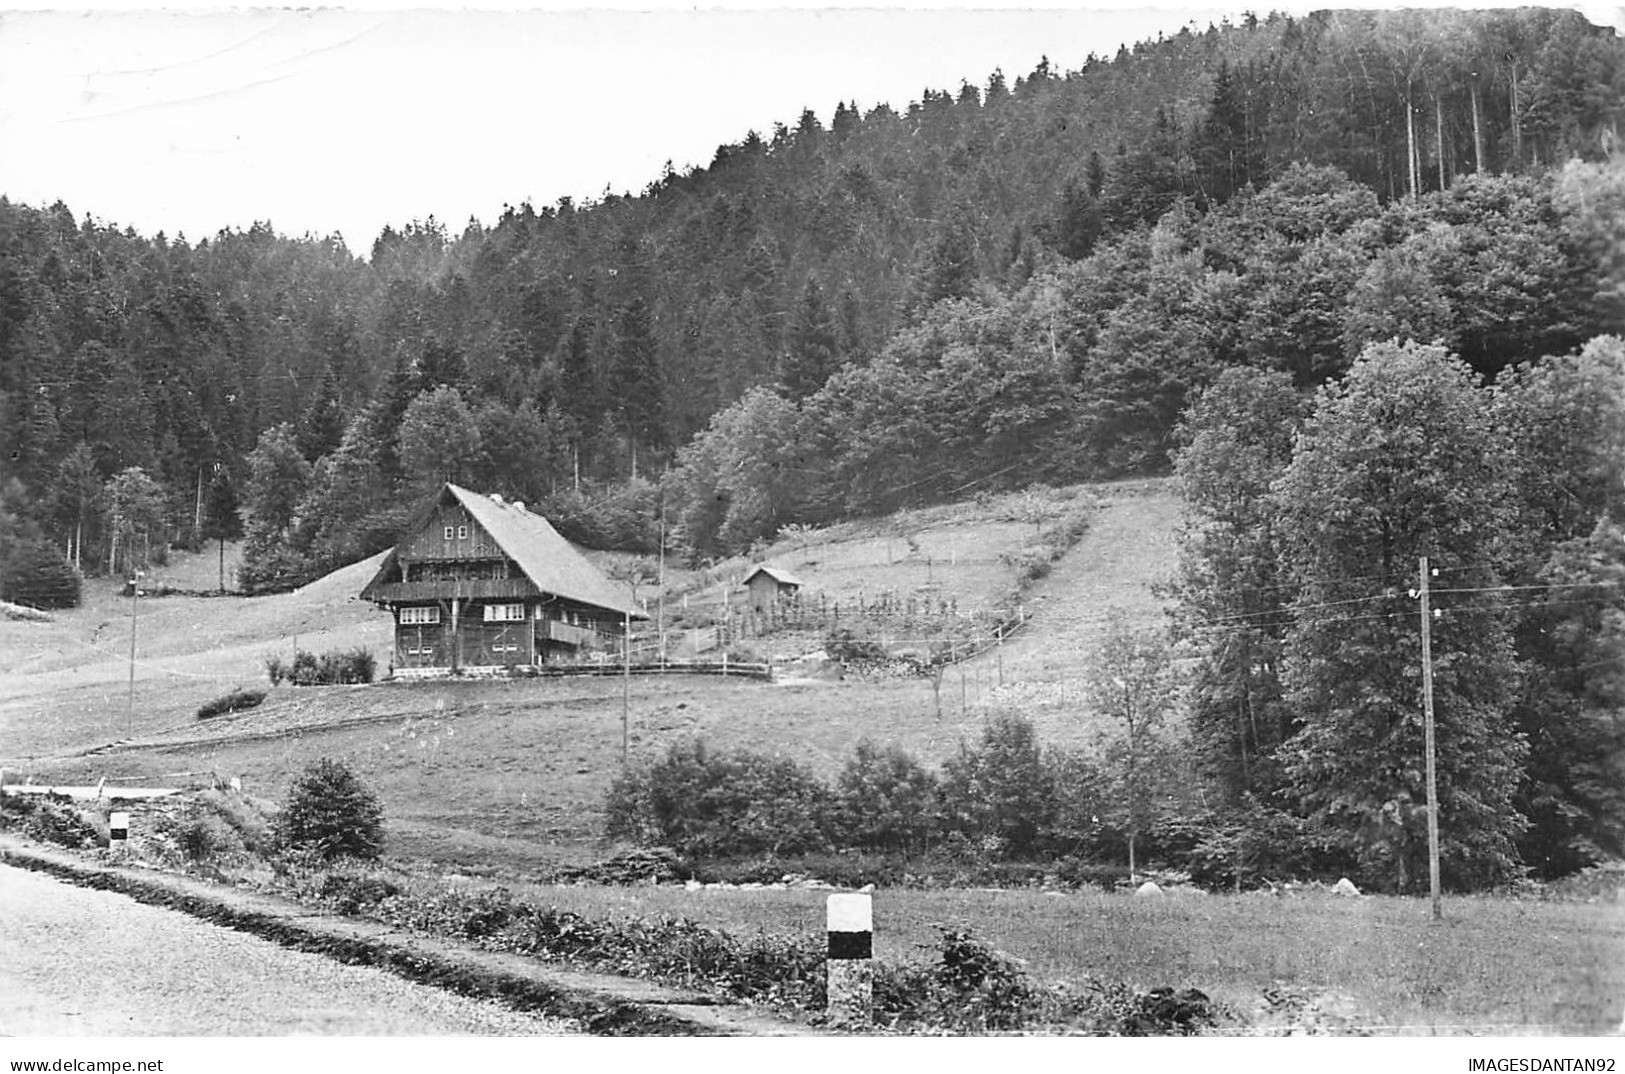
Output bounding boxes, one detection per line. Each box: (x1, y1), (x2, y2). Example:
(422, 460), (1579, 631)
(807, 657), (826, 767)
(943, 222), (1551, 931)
(0, 10), (1625, 585)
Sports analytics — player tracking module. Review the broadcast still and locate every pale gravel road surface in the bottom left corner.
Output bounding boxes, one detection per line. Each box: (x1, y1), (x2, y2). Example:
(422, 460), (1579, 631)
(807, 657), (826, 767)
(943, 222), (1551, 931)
(0, 866), (572, 1037)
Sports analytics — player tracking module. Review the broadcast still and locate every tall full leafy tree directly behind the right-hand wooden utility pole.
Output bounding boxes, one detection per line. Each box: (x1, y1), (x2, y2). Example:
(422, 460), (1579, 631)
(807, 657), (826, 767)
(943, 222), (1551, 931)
(1277, 343), (1528, 890)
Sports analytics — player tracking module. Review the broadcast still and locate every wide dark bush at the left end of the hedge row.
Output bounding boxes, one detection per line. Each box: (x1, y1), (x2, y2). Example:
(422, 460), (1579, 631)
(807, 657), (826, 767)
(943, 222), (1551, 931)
(605, 739), (830, 856)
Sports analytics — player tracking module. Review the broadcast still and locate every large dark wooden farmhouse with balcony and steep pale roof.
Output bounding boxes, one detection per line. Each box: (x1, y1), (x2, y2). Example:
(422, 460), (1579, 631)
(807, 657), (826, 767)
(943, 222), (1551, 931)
(361, 484), (648, 671)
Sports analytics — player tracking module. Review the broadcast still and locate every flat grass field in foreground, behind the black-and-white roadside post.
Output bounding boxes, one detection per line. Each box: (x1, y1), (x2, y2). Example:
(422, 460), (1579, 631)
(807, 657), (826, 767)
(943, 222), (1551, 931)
(461, 886), (1625, 1035)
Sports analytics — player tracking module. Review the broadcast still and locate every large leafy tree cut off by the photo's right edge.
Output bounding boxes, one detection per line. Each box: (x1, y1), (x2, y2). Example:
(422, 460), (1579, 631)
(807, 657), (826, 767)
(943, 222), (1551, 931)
(1495, 336), (1625, 876)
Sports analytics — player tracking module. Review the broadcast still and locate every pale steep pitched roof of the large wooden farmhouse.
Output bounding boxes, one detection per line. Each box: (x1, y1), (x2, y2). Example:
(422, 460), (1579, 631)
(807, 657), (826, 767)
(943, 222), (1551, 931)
(362, 483), (648, 619)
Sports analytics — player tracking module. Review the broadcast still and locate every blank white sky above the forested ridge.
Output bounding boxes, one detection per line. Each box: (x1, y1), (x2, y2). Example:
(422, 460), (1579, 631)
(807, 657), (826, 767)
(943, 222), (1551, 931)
(0, 0), (1620, 255)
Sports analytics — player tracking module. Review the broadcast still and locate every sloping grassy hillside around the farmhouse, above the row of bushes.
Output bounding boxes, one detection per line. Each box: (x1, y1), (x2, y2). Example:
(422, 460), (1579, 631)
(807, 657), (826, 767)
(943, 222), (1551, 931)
(0, 481), (1178, 871)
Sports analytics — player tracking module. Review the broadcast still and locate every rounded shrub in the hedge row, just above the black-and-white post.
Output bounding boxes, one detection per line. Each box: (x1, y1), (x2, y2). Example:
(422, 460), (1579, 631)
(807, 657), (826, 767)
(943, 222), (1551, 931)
(835, 739), (941, 850)
